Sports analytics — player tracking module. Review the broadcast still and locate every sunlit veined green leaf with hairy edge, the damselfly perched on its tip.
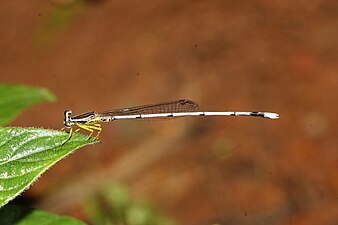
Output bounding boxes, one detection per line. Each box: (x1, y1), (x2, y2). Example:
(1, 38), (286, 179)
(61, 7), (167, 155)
(0, 127), (95, 207)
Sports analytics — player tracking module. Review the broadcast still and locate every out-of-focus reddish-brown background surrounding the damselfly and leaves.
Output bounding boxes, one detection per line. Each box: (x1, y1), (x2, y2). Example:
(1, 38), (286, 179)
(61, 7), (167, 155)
(0, 0), (338, 225)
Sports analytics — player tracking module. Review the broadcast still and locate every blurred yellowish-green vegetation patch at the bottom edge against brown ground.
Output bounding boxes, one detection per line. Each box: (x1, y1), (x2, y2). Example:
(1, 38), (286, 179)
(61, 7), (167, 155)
(83, 184), (177, 225)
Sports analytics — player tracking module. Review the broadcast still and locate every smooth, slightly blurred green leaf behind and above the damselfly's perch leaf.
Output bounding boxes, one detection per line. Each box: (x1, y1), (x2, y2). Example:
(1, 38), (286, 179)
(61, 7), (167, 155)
(0, 84), (56, 126)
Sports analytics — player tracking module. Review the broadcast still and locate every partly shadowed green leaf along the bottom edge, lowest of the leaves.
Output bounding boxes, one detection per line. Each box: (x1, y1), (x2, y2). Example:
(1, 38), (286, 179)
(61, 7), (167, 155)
(0, 205), (85, 225)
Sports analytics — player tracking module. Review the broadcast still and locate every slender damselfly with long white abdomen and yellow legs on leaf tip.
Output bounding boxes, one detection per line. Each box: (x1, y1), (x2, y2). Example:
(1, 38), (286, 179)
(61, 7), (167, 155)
(62, 99), (279, 144)
